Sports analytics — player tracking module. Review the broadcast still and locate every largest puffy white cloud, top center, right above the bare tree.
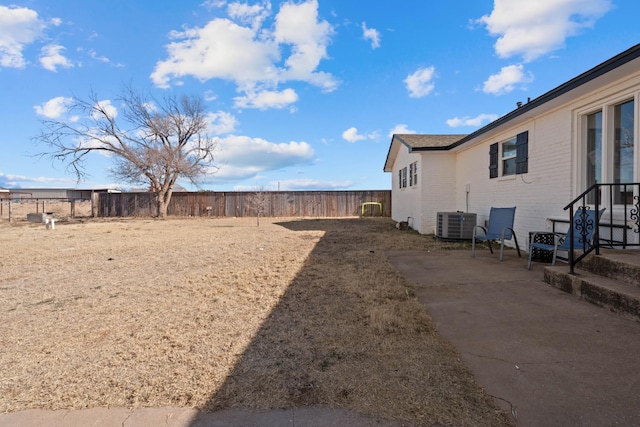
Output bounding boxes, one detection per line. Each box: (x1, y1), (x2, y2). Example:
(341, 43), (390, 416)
(150, 0), (338, 108)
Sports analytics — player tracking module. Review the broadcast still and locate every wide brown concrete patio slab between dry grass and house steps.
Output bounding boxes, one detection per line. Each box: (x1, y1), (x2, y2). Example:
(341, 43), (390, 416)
(387, 250), (640, 426)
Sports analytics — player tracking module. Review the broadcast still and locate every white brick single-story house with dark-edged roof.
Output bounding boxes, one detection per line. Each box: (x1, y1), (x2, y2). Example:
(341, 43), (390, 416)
(384, 44), (640, 249)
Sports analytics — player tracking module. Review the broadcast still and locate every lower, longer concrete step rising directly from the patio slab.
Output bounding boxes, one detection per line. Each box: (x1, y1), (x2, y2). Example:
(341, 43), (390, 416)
(544, 265), (640, 322)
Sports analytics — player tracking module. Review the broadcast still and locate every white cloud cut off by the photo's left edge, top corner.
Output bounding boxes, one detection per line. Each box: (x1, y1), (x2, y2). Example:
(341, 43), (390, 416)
(0, 5), (45, 68)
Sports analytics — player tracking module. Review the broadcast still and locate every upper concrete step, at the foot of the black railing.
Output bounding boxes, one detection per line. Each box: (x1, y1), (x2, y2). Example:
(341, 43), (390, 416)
(578, 249), (640, 287)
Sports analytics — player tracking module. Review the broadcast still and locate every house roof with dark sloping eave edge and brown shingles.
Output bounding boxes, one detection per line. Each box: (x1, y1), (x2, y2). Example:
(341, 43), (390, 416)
(384, 44), (640, 172)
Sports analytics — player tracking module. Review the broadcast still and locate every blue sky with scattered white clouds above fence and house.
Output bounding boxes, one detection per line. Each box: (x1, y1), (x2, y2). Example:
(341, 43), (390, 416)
(0, 0), (640, 191)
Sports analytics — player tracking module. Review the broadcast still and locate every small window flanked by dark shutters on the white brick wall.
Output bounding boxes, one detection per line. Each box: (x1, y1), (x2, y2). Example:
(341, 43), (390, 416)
(489, 131), (529, 178)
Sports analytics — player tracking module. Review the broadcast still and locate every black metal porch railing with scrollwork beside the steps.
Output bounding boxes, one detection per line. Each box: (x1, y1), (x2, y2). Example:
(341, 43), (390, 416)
(564, 182), (640, 274)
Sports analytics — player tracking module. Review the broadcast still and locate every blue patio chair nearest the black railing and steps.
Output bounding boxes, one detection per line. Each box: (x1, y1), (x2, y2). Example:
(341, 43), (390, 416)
(527, 207), (605, 270)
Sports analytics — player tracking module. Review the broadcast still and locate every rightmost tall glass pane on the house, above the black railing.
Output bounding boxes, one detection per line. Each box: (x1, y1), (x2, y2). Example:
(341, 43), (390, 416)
(613, 101), (634, 204)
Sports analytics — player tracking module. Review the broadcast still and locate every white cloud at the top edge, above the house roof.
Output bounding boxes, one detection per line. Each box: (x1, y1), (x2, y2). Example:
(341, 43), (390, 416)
(476, 0), (611, 62)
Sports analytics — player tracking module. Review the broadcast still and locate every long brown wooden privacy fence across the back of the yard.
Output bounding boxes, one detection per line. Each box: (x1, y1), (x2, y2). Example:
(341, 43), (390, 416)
(94, 190), (391, 217)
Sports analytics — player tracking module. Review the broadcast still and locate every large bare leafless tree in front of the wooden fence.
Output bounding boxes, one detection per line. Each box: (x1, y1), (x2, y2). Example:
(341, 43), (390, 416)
(35, 87), (217, 218)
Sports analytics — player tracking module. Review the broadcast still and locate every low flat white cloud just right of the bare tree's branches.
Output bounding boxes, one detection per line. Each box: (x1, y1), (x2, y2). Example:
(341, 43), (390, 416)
(214, 135), (314, 180)
